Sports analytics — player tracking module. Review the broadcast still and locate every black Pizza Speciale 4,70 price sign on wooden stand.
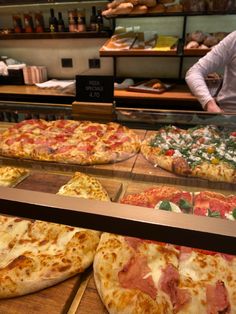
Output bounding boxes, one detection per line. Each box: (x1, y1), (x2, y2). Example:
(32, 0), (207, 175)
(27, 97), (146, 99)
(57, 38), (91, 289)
(76, 75), (114, 103)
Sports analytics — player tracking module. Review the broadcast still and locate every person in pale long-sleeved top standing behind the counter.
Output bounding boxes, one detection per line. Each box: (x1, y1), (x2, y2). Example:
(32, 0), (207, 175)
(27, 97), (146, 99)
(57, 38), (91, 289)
(185, 31), (236, 113)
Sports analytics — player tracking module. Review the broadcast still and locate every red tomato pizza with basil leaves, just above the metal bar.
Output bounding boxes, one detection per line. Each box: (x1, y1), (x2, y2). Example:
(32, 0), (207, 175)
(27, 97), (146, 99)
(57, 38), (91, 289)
(120, 185), (236, 220)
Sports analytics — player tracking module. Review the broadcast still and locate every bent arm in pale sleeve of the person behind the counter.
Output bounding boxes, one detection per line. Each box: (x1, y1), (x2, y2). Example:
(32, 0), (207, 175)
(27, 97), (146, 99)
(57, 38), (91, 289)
(185, 32), (236, 112)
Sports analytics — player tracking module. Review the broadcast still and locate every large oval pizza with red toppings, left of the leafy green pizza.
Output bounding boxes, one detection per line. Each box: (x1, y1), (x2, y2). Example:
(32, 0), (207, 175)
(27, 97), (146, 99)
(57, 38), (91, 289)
(0, 119), (140, 165)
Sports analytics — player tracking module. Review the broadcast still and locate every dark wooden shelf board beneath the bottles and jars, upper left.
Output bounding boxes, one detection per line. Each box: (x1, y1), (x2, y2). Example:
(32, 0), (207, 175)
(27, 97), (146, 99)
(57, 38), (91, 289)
(0, 31), (110, 40)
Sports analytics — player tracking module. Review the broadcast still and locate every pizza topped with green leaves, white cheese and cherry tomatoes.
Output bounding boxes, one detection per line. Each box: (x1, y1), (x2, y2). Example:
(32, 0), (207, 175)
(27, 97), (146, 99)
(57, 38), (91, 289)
(141, 126), (236, 183)
